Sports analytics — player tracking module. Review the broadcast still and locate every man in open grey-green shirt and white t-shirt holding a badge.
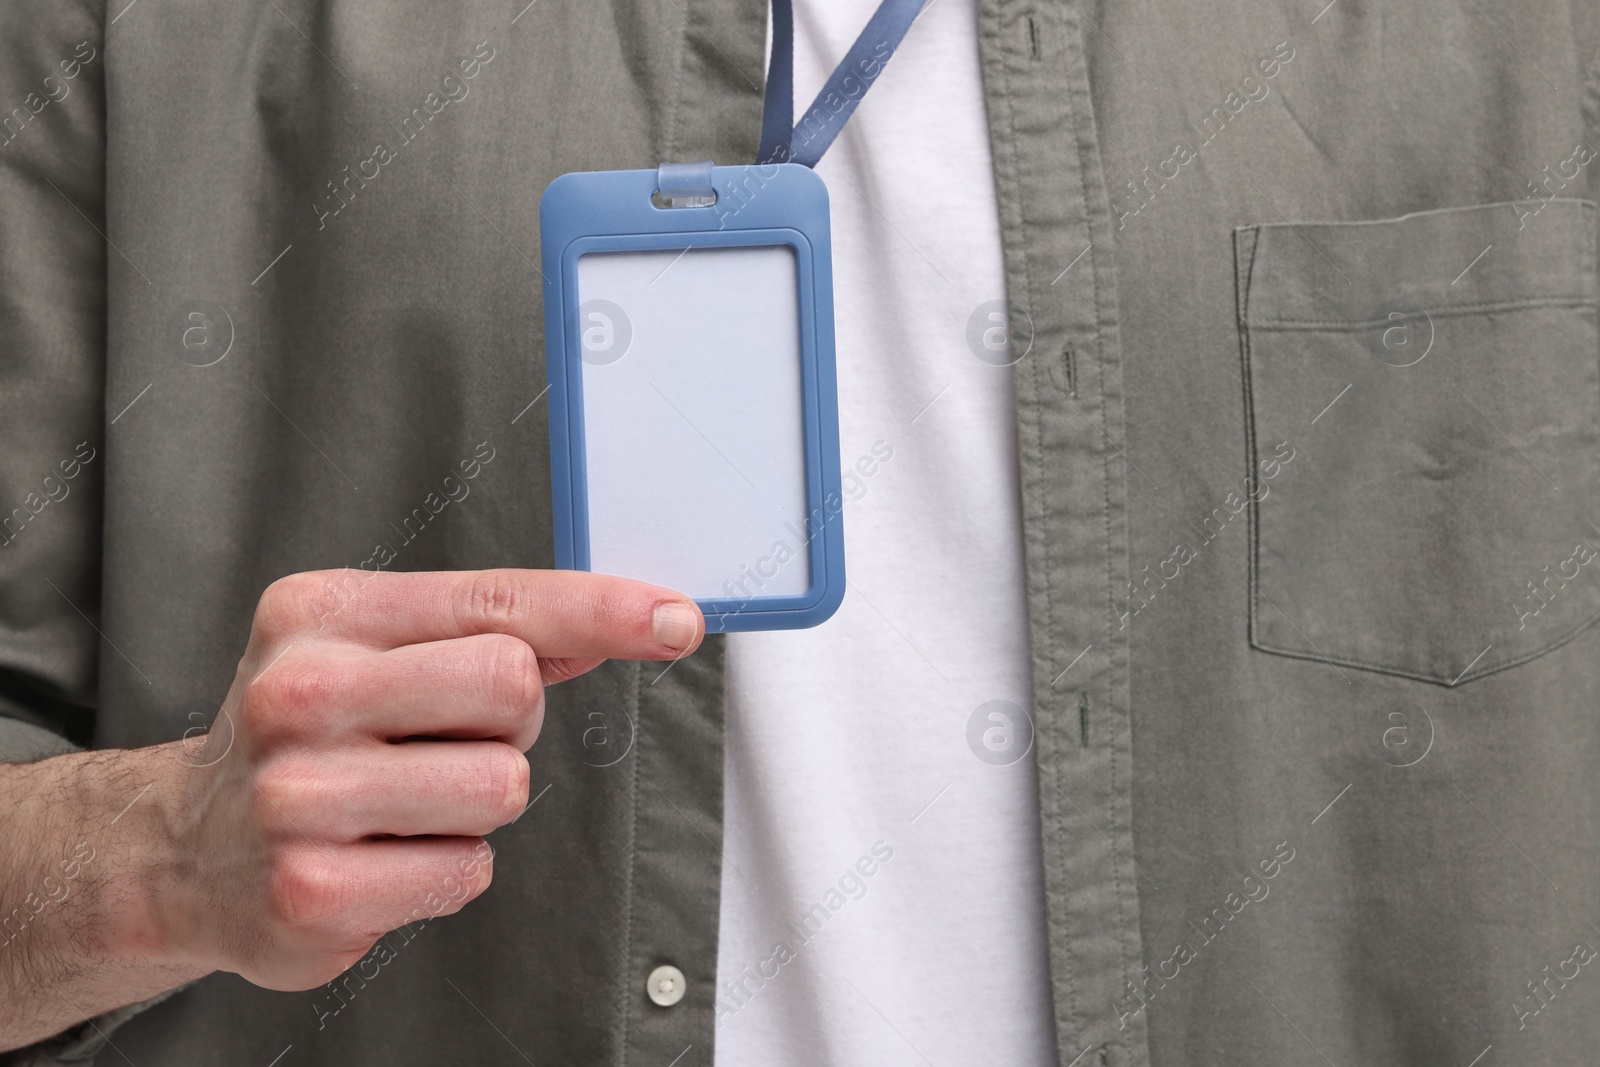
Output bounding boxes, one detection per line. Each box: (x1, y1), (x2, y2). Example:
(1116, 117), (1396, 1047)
(0, 0), (1600, 1067)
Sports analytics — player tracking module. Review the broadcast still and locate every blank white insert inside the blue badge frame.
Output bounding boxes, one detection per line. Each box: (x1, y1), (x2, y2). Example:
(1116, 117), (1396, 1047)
(578, 245), (811, 600)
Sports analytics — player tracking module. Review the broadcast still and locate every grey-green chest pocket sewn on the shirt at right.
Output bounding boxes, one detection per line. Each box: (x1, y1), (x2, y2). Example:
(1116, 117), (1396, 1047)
(1235, 200), (1600, 685)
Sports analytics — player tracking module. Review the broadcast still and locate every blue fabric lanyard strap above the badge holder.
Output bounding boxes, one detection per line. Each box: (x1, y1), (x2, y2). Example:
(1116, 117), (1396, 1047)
(755, 0), (922, 166)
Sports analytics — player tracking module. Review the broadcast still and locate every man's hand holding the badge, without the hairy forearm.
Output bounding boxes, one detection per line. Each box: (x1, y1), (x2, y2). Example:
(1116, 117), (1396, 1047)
(227, 569), (706, 989)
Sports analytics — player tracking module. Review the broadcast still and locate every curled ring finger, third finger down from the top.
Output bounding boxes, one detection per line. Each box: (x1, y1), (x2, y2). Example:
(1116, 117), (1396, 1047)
(256, 741), (528, 845)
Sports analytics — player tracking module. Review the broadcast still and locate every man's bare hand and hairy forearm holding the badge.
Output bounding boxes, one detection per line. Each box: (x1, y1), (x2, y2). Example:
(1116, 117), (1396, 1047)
(0, 569), (704, 1049)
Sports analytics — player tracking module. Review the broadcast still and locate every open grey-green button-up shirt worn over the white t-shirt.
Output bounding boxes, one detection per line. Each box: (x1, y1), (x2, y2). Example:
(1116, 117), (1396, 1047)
(0, 0), (1600, 1067)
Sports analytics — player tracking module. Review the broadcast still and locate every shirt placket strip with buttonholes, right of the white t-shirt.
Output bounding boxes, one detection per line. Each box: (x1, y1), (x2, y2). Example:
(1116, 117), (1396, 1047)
(979, 0), (1149, 1065)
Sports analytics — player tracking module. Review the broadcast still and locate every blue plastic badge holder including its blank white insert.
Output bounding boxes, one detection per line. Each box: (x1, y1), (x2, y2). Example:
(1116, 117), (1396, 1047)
(539, 163), (845, 633)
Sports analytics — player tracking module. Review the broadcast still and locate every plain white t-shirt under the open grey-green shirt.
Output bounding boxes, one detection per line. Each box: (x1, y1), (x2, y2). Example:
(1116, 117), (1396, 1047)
(717, 0), (1054, 1067)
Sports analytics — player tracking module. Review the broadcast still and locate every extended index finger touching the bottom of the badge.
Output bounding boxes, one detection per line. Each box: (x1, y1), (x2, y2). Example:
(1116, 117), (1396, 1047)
(272, 568), (706, 659)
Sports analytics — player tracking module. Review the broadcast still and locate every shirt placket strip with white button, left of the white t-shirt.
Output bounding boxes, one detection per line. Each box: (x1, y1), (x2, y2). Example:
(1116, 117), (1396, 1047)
(616, 0), (766, 1067)
